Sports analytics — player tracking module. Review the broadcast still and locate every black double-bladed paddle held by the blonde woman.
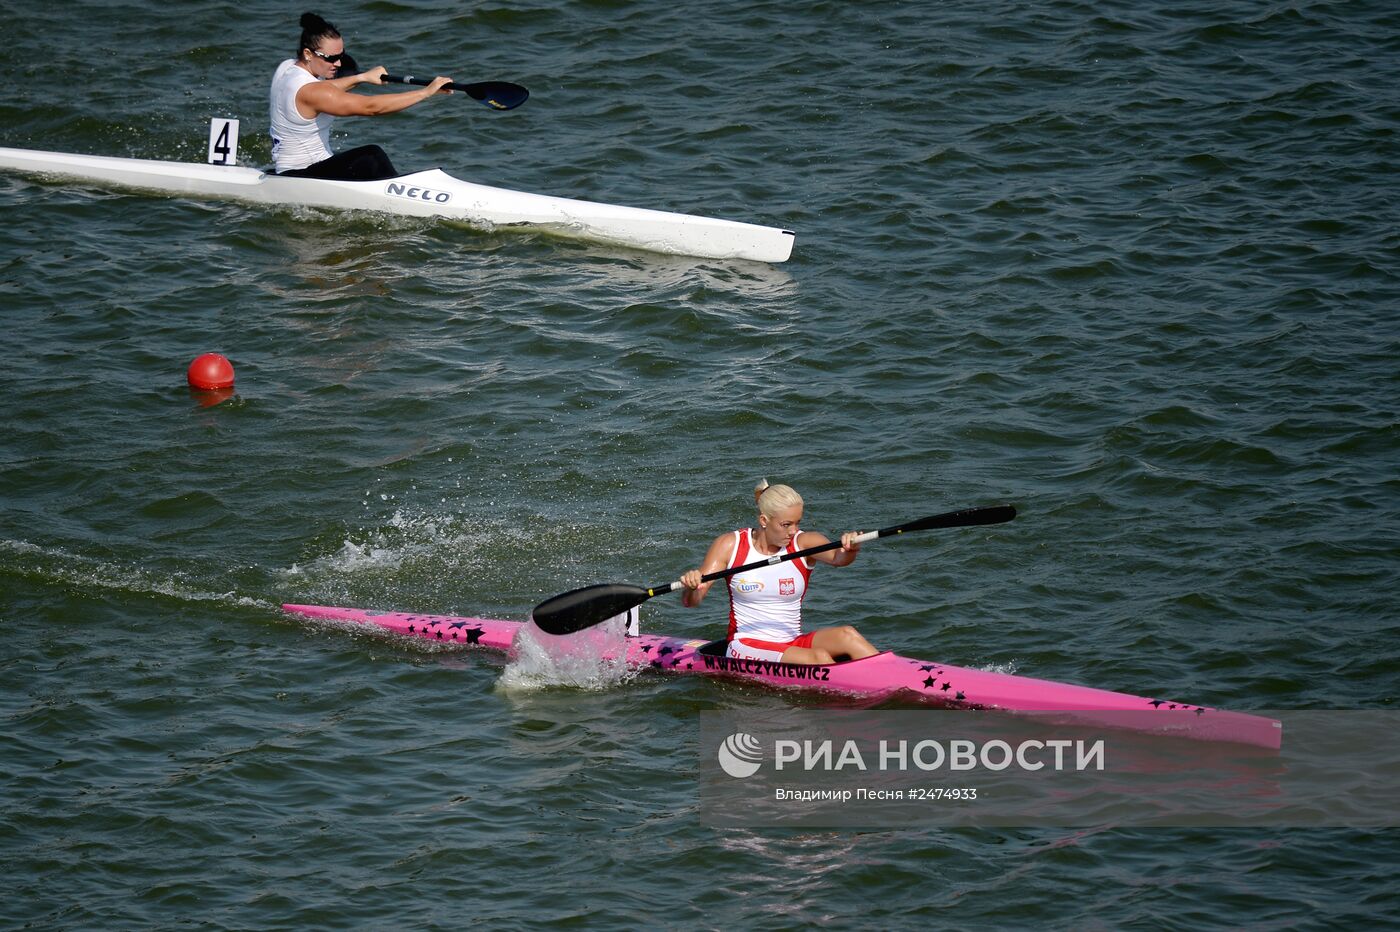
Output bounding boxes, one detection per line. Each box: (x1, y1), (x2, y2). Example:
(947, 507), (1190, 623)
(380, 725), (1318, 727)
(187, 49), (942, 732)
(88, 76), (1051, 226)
(532, 505), (1016, 634)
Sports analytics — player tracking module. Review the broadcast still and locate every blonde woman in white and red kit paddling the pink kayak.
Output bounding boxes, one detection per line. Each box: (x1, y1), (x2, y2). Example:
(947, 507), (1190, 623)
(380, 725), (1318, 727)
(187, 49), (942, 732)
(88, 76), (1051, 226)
(680, 479), (879, 663)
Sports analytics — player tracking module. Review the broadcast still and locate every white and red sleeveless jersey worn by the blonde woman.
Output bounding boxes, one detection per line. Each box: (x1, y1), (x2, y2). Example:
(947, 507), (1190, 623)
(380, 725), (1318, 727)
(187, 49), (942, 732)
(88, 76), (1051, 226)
(727, 528), (812, 642)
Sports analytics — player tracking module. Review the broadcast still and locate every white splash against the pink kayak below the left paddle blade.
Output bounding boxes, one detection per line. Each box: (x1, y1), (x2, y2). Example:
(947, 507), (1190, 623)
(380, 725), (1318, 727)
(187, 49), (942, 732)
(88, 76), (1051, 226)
(497, 616), (637, 691)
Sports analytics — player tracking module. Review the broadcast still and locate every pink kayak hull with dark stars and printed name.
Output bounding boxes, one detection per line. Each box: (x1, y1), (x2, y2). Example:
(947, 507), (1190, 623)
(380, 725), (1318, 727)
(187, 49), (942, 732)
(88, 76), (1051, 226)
(283, 605), (1282, 749)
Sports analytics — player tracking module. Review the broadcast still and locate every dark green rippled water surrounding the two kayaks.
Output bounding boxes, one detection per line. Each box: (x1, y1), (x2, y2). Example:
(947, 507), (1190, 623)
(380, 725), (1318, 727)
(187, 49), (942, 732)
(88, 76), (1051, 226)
(0, 0), (1400, 929)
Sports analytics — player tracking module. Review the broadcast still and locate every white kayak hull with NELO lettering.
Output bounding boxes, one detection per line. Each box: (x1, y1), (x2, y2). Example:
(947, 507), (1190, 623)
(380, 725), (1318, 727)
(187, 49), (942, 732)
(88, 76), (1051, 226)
(0, 147), (795, 262)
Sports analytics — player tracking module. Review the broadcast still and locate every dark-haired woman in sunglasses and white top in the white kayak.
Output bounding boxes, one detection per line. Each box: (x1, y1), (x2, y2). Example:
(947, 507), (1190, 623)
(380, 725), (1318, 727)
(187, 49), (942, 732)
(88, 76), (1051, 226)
(270, 13), (452, 181)
